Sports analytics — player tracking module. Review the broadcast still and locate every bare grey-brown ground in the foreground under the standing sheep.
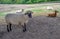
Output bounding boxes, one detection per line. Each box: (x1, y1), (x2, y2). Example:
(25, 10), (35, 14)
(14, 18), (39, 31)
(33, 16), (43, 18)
(0, 16), (60, 39)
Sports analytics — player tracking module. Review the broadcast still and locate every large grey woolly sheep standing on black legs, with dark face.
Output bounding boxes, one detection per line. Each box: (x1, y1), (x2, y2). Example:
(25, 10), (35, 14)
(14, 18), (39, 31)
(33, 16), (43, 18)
(5, 11), (33, 32)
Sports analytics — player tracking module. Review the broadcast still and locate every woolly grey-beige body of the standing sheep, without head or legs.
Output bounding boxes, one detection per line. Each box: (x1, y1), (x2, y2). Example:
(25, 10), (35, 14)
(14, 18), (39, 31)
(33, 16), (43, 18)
(6, 14), (28, 25)
